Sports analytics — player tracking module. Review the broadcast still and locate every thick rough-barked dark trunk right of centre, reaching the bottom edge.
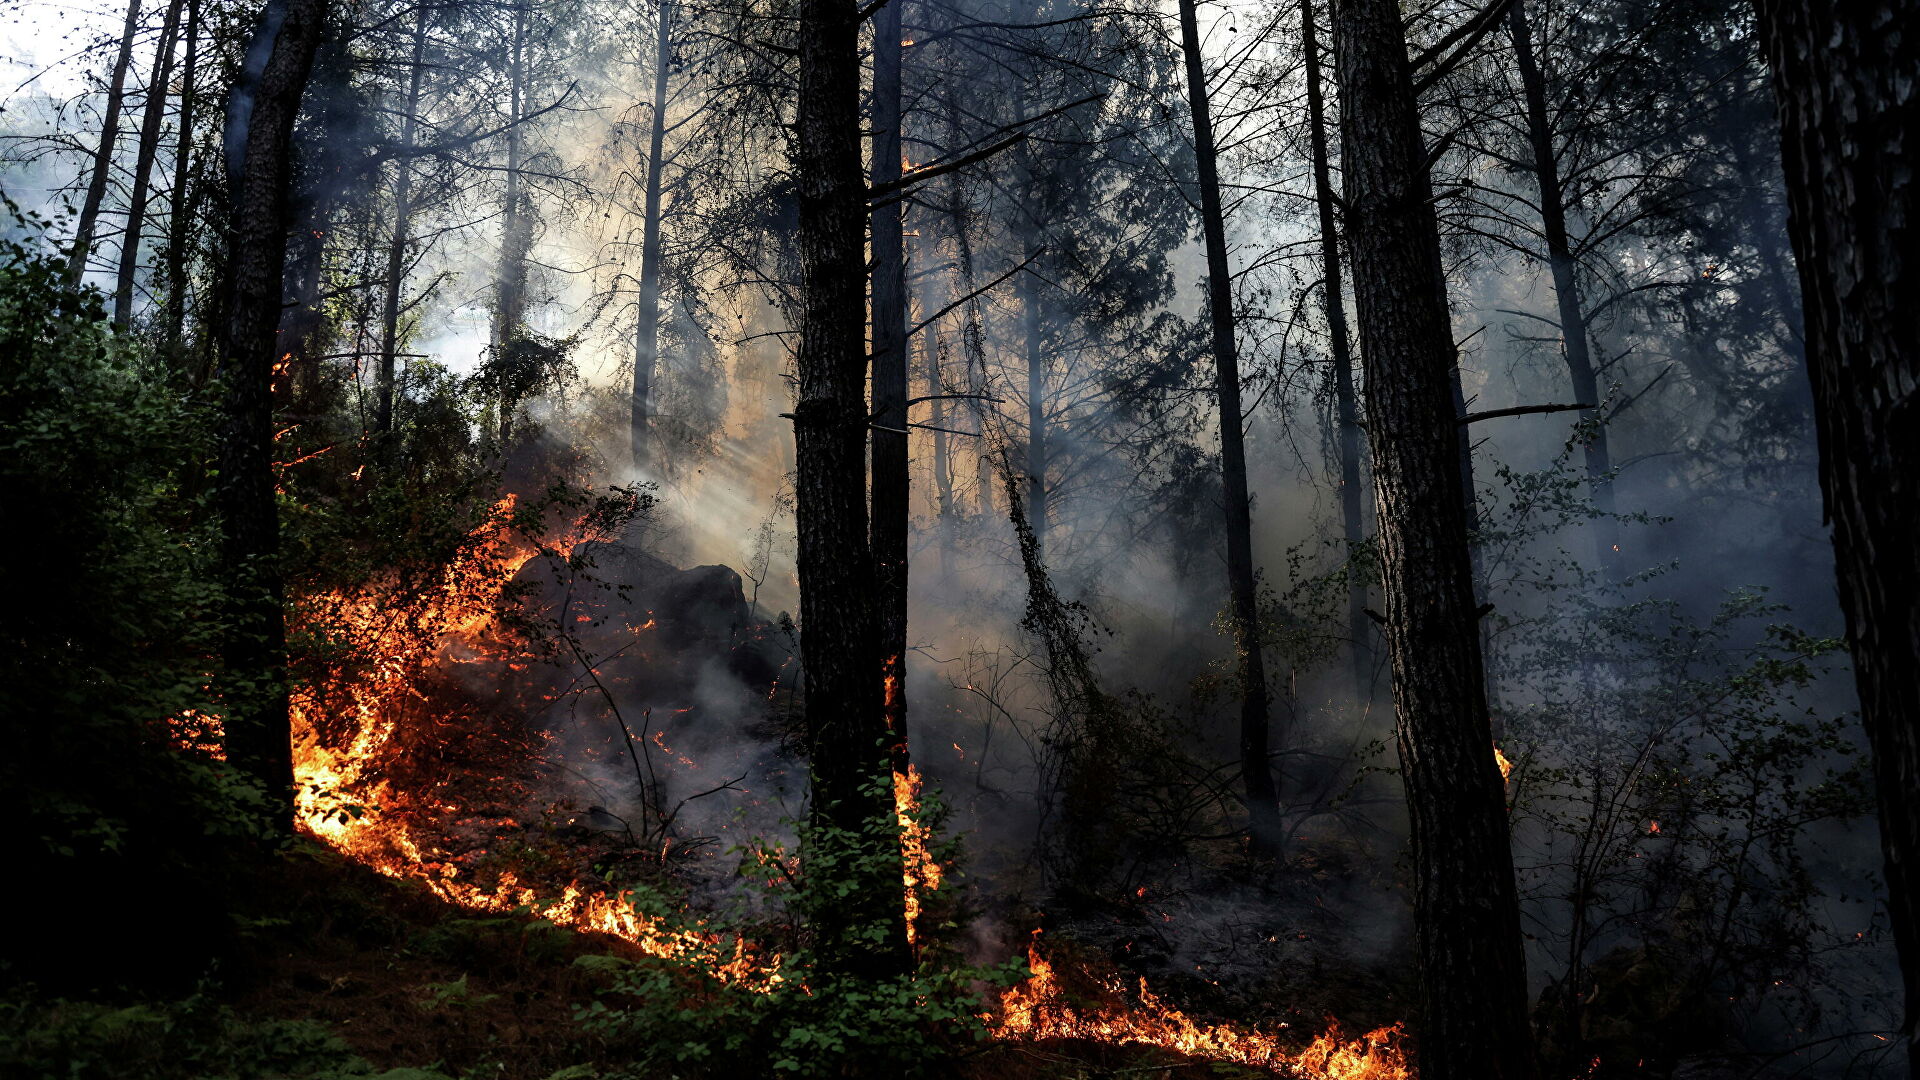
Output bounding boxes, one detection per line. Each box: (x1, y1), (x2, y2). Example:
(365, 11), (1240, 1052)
(1334, 0), (1534, 1080)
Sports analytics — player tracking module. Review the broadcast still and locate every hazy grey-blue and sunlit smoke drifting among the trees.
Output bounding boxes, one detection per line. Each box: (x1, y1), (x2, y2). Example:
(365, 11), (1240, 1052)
(8, 4), (1891, 1060)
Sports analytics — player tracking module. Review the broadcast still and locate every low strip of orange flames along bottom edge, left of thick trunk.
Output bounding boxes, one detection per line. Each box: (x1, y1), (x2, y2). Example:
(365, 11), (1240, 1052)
(987, 940), (1413, 1080)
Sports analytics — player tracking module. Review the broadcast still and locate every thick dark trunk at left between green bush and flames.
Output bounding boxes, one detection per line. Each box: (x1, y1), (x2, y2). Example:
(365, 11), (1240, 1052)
(213, 0), (326, 832)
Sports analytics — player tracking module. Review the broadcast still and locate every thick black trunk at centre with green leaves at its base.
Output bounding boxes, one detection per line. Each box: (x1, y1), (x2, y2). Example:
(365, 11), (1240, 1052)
(793, 0), (910, 978)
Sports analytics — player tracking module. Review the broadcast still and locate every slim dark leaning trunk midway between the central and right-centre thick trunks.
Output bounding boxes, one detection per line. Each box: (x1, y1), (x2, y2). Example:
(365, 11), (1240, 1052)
(1181, 0), (1281, 853)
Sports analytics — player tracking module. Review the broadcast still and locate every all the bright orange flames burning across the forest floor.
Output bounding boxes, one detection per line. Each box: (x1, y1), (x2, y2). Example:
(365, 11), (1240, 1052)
(294, 498), (1411, 1080)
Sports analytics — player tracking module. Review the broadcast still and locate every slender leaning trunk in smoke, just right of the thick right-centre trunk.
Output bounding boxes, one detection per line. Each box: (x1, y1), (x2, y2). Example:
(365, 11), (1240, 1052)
(1507, 0), (1620, 580)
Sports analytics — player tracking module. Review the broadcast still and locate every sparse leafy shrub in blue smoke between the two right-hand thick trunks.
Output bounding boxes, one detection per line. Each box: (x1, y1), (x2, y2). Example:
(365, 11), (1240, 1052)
(1488, 451), (1872, 1068)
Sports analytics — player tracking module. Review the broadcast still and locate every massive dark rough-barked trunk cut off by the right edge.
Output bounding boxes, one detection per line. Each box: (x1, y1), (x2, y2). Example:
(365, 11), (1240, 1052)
(1759, 0), (1920, 1076)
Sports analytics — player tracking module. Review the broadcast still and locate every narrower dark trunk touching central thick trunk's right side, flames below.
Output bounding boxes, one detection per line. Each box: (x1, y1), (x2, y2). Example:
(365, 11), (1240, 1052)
(870, 0), (910, 773)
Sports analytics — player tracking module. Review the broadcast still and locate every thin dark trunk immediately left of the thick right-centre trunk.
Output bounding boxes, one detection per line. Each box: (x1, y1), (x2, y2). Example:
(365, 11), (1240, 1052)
(1300, 0), (1373, 703)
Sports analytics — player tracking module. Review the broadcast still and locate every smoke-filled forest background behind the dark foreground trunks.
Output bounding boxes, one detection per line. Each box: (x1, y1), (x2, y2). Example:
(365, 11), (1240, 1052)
(0, 0), (1901, 1076)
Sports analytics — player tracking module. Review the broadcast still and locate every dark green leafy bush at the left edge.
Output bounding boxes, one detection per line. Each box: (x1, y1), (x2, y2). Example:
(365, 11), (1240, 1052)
(0, 204), (274, 978)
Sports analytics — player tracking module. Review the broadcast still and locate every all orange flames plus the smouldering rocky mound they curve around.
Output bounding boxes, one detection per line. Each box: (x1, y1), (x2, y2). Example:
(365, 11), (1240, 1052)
(294, 490), (1407, 1080)
